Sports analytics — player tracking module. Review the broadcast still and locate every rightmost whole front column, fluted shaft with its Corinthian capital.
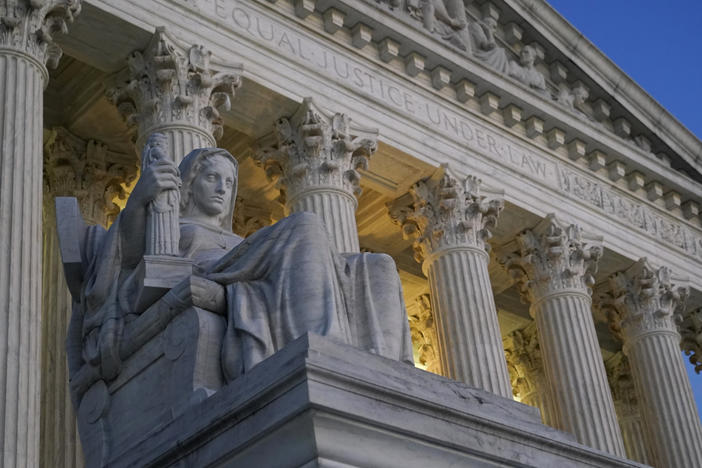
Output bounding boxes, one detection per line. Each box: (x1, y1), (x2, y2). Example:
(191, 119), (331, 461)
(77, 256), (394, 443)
(610, 258), (702, 468)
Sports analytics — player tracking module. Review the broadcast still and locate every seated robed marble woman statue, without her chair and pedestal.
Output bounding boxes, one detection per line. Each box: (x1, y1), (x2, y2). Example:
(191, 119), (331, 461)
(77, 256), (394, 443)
(69, 143), (412, 388)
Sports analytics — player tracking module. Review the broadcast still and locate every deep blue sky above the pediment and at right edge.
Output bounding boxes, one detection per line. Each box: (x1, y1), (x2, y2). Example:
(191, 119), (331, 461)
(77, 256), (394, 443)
(547, 0), (702, 411)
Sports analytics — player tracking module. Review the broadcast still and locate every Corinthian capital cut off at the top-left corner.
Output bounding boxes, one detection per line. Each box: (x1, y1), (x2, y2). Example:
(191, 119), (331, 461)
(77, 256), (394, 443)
(0, 0), (81, 69)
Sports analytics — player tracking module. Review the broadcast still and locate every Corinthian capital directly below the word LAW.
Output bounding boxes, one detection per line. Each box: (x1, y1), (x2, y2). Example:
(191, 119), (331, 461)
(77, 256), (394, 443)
(501, 214), (602, 304)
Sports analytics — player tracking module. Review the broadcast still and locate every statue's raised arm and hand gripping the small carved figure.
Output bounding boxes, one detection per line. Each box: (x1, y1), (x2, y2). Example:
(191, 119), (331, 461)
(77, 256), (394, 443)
(120, 160), (180, 267)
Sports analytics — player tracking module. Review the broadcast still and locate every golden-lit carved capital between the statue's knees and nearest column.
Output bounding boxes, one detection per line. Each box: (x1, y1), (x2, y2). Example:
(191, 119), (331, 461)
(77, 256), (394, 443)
(409, 294), (441, 374)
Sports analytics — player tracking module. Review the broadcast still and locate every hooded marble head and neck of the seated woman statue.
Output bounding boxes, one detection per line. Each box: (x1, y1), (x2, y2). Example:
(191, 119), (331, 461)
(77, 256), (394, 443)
(179, 148), (239, 232)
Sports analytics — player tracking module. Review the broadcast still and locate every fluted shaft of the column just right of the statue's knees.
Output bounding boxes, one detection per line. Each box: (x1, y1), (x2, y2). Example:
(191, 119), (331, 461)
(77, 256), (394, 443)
(427, 248), (512, 398)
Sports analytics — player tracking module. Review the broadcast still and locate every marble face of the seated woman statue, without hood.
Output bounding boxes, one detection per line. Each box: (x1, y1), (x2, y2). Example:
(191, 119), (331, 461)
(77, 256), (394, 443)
(192, 155), (236, 216)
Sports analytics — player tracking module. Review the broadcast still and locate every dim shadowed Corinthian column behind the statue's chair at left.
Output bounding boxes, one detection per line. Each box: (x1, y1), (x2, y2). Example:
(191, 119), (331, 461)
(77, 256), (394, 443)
(39, 128), (137, 468)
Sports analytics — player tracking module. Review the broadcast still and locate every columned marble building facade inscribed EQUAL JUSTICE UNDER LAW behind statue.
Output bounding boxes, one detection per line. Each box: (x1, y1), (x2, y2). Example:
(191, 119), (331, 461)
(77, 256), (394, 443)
(0, 0), (702, 467)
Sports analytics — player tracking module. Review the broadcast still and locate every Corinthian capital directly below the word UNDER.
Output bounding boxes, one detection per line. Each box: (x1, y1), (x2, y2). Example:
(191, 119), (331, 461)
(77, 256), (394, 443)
(389, 165), (504, 262)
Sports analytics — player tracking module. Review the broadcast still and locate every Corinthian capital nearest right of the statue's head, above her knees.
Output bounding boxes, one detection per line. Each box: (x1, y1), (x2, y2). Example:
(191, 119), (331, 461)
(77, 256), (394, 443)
(255, 98), (378, 200)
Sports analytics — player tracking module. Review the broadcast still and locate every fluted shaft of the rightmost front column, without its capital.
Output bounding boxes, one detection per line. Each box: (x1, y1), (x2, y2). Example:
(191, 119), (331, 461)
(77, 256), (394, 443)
(626, 333), (702, 468)
